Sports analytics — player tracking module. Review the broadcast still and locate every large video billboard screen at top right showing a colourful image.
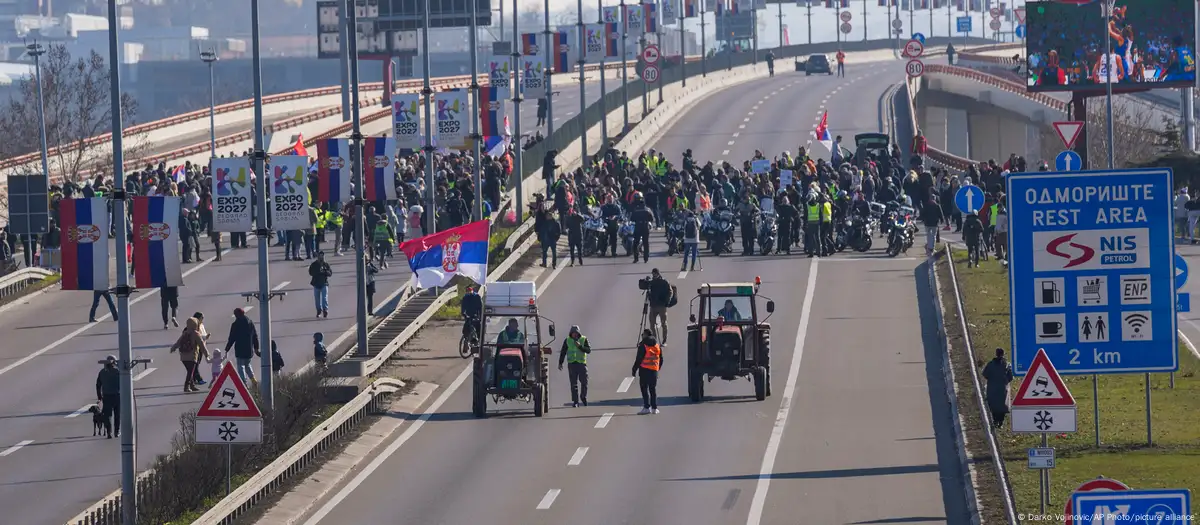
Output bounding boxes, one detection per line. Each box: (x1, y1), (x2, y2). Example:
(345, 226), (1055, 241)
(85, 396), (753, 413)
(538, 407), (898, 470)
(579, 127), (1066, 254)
(1025, 0), (1196, 91)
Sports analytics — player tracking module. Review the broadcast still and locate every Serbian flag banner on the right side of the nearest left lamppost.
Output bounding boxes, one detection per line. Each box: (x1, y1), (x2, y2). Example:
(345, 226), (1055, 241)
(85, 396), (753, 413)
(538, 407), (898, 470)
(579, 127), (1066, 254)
(133, 197), (184, 289)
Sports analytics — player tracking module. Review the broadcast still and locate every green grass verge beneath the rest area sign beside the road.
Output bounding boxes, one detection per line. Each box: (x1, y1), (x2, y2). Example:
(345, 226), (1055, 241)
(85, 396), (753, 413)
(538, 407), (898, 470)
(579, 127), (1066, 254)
(942, 249), (1200, 523)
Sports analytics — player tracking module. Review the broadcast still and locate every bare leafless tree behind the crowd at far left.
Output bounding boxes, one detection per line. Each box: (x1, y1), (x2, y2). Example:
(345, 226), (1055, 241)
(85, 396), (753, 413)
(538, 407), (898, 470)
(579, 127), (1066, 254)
(0, 46), (145, 184)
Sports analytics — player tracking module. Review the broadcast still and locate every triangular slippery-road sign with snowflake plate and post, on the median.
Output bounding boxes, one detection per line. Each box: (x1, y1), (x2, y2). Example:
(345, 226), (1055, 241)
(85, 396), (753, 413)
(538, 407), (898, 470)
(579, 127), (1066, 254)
(196, 361), (263, 495)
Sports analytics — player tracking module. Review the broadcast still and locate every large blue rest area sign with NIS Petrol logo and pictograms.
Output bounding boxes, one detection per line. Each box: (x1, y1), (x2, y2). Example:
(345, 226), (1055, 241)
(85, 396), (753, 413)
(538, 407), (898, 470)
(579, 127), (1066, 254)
(1006, 168), (1178, 375)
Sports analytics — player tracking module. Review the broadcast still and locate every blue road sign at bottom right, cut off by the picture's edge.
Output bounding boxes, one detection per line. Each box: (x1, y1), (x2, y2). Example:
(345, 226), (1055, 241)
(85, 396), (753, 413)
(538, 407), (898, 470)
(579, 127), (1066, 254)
(1070, 489), (1193, 525)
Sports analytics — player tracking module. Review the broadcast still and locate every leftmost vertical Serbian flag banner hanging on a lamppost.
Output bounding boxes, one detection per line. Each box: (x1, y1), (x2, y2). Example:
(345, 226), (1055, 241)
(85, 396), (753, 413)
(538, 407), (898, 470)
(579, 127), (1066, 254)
(59, 198), (108, 290)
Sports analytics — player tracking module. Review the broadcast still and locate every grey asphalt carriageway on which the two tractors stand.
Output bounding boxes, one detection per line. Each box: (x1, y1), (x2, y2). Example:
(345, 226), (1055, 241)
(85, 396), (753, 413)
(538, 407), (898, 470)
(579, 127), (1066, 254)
(305, 64), (970, 525)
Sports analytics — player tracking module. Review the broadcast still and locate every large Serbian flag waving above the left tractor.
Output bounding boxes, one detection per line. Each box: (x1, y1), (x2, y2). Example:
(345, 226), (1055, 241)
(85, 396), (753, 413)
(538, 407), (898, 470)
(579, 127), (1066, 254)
(400, 221), (488, 289)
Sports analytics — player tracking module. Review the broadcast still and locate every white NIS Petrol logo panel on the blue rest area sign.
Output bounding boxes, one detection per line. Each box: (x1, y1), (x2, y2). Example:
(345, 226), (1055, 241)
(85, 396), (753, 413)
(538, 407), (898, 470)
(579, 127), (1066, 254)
(1033, 228), (1150, 271)
